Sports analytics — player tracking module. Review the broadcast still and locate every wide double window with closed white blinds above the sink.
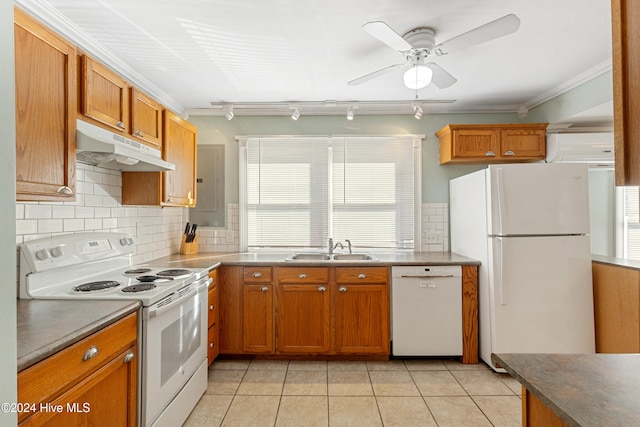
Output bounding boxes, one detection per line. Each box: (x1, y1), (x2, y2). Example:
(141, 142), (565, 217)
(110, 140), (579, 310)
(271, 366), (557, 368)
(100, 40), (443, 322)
(240, 135), (421, 250)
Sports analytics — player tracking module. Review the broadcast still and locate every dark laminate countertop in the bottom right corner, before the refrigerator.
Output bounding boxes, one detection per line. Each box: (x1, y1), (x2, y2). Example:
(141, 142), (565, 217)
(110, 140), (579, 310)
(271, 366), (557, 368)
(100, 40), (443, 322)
(492, 354), (640, 427)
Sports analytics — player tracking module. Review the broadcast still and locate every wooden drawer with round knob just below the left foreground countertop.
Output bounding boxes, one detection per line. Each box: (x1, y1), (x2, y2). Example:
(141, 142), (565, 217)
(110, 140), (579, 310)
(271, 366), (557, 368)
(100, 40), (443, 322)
(18, 313), (138, 415)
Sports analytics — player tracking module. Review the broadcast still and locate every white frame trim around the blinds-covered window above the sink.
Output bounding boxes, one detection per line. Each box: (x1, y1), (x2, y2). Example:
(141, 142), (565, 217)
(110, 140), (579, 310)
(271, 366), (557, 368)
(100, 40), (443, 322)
(236, 134), (425, 252)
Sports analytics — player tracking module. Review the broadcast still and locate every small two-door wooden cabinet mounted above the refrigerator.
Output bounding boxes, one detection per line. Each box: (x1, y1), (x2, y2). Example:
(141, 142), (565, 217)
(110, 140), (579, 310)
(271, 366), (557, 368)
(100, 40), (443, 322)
(436, 123), (547, 164)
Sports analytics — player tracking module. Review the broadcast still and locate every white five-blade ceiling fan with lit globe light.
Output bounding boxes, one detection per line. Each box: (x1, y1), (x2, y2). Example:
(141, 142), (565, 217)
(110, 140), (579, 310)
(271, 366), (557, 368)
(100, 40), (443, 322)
(347, 14), (520, 90)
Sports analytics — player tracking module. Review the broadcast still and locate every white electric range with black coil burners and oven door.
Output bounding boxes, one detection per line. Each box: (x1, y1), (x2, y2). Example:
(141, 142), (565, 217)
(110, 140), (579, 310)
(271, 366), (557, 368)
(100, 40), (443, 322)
(19, 233), (211, 426)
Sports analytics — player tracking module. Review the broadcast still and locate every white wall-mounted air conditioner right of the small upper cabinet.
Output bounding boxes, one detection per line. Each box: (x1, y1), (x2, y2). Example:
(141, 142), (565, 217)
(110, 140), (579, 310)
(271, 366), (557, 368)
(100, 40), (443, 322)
(547, 132), (614, 167)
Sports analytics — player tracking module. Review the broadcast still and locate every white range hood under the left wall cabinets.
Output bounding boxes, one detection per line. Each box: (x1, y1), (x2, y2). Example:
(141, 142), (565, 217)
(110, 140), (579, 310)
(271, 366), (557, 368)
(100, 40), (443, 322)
(76, 119), (176, 172)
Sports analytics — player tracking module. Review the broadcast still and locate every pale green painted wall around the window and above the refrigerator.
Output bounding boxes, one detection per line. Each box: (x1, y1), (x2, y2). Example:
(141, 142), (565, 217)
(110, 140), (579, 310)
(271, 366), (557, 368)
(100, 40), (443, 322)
(189, 71), (613, 224)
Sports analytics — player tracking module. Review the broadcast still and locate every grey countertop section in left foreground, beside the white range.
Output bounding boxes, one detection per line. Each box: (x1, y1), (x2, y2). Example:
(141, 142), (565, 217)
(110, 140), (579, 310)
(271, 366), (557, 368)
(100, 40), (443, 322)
(17, 299), (140, 372)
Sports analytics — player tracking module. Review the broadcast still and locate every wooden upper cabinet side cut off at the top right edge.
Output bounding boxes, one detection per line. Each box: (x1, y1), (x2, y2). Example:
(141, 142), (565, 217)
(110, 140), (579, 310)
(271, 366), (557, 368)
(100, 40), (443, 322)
(611, 0), (640, 186)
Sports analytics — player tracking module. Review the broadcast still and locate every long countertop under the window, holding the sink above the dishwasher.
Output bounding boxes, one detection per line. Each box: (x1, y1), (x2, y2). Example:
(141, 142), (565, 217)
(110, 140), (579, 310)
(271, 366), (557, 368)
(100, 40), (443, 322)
(147, 251), (480, 269)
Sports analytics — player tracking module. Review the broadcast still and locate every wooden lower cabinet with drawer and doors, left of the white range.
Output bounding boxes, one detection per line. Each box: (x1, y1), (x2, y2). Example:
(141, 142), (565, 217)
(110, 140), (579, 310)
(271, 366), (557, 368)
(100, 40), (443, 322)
(18, 313), (138, 426)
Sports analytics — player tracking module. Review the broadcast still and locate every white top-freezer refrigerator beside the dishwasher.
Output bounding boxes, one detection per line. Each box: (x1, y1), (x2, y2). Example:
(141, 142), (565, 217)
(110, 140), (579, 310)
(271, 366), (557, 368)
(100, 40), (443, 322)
(449, 163), (595, 372)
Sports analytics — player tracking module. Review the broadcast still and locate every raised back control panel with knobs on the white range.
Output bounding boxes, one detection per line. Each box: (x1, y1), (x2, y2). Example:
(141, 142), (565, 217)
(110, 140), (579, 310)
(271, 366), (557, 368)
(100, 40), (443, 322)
(20, 233), (135, 273)
